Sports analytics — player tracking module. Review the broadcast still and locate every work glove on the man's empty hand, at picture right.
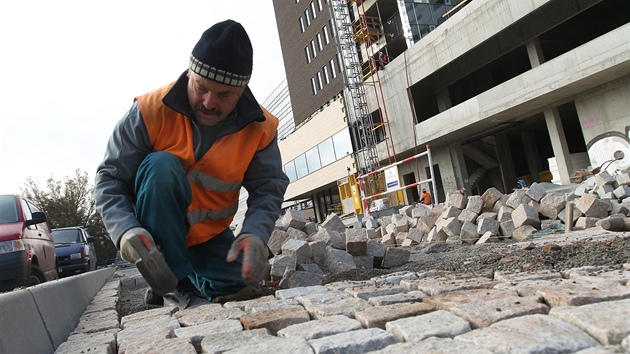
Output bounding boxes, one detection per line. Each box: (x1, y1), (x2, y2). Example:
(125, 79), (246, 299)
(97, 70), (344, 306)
(226, 233), (271, 284)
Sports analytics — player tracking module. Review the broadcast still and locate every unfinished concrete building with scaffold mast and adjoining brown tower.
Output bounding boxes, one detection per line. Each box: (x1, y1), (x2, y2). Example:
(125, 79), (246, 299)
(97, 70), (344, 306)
(273, 0), (630, 221)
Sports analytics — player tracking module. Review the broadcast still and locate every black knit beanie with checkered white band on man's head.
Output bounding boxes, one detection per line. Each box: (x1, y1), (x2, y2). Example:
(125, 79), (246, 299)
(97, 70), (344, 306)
(189, 20), (253, 86)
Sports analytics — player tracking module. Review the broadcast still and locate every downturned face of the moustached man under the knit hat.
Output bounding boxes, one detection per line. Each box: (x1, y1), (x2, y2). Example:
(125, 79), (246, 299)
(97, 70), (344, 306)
(187, 71), (247, 126)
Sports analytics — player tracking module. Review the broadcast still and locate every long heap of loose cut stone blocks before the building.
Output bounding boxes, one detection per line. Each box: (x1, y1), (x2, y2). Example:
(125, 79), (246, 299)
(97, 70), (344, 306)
(268, 166), (630, 289)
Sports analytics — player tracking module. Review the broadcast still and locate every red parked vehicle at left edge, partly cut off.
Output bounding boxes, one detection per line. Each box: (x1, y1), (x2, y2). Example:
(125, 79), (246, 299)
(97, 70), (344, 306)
(0, 194), (58, 291)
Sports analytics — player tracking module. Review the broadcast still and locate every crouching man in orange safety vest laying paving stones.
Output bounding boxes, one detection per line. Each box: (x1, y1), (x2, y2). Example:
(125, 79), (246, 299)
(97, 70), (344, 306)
(94, 20), (288, 307)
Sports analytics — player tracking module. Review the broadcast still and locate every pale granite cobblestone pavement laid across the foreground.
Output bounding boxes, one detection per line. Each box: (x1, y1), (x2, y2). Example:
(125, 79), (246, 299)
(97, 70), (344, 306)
(56, 232), (630, 354)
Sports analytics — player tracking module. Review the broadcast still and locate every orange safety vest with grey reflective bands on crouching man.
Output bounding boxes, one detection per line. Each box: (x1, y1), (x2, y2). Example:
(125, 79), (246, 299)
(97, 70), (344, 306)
(136, 84), (278, 247)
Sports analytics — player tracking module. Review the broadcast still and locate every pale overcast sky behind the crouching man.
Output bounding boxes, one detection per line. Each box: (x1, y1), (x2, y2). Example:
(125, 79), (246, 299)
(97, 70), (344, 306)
(0, 0), (285, 194)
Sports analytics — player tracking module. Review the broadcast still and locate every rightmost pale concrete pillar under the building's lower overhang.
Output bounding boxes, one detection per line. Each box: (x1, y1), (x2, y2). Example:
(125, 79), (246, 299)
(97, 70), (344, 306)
(544, 108), (573, 185)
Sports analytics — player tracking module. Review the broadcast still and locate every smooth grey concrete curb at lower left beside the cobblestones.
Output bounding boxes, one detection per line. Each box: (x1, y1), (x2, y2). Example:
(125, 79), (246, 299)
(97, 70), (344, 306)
(0, 267), (116, 354)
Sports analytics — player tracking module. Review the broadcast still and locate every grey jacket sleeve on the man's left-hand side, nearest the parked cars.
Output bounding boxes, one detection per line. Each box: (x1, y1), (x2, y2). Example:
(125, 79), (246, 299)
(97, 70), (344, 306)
(94, 102), (153, 247)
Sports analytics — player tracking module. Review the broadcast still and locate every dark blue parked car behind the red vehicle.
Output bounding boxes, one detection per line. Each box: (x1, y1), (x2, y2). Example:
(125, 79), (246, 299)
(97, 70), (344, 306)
(52, 226), (97, 277)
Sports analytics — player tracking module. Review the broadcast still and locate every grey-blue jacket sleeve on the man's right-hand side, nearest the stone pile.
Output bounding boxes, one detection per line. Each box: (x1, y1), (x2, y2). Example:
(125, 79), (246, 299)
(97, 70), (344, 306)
(241, 135), (289, 244)
